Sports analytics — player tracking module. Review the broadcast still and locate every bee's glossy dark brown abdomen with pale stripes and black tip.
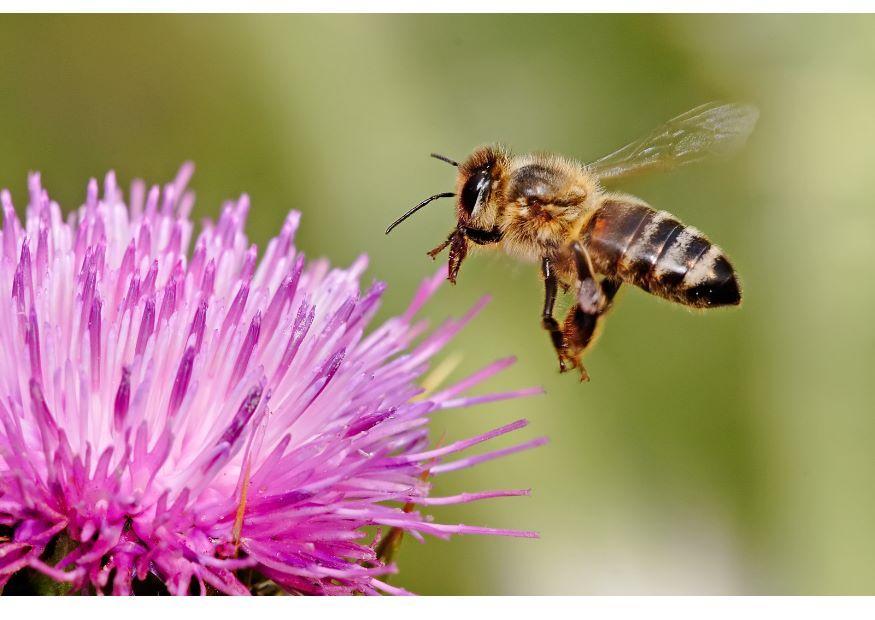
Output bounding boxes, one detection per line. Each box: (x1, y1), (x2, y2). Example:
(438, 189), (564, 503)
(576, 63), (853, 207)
(581, 199), (741, 308)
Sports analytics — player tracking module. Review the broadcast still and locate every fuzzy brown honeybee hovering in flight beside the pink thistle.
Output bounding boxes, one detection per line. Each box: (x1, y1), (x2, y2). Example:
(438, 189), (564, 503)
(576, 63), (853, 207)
(386, 103), (759, 381)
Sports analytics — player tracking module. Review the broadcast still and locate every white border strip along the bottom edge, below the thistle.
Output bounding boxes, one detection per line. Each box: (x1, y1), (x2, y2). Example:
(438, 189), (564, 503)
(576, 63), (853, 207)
(0, 596), (875, 620)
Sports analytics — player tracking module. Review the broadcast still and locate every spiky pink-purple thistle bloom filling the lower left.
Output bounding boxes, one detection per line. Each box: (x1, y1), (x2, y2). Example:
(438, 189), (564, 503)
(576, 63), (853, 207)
(0, 165), (544, 594)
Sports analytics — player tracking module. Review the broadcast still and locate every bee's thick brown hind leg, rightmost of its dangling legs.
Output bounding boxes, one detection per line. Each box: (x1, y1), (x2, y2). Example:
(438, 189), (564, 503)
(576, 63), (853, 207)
(563, 243), (620, 381)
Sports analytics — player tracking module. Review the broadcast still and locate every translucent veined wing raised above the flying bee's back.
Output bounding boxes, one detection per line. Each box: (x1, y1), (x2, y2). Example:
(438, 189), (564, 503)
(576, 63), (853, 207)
(589, 103), (760, 179)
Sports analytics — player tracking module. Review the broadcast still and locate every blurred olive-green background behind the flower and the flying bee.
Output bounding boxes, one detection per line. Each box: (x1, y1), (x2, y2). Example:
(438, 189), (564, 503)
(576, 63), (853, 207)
(0, 15), (875, 594)
